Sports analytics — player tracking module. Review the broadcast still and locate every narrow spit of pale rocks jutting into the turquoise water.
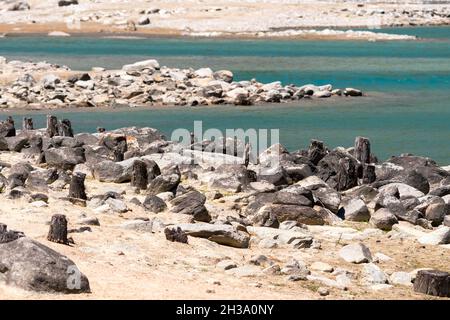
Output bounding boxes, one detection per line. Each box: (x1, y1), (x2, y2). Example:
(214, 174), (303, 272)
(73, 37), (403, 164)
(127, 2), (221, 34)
(0, 58), (362, 108)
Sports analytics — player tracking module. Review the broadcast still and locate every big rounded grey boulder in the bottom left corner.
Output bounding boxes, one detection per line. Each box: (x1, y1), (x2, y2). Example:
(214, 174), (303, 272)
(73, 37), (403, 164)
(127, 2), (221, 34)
(0, 237), (90, 293)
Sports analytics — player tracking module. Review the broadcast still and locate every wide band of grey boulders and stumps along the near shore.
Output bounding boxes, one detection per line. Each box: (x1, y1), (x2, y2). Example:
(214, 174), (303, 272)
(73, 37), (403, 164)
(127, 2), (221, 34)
(0, 116), (450, 295)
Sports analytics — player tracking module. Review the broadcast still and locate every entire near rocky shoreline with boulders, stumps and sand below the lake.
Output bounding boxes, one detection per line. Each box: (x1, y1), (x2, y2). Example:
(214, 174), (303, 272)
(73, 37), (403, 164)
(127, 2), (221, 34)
(0, 116), (450, 299)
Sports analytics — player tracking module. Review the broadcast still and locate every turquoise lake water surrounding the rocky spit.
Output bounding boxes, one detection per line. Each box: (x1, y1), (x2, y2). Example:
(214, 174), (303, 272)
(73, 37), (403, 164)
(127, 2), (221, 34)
(0, 27), (450, 165)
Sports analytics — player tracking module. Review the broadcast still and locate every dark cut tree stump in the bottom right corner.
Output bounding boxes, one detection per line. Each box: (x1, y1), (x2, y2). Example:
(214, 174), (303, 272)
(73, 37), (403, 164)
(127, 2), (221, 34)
(414, 270), (450, 298)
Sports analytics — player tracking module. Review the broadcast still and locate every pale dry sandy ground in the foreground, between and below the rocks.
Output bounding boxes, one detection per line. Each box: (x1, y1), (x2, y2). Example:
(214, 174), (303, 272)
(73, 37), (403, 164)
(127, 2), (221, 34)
(0, 153), (450, 299)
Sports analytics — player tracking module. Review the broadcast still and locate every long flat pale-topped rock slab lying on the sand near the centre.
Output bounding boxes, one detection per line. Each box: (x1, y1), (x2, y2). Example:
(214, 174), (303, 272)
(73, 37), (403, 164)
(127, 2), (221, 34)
(175, 223), (250, 248)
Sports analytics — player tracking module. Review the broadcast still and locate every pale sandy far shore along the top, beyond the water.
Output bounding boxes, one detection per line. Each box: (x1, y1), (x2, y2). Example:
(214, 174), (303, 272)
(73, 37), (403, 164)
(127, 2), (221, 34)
(0, 0), (450, 38)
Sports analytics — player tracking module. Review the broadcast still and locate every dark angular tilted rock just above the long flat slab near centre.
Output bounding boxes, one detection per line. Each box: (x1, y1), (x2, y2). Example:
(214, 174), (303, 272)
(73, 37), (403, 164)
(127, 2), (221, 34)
(170, 190), (211, 222)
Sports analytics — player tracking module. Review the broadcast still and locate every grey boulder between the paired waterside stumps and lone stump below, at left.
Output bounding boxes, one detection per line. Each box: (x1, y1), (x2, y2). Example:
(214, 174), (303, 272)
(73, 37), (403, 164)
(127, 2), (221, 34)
(44, 147), (85, 170)
